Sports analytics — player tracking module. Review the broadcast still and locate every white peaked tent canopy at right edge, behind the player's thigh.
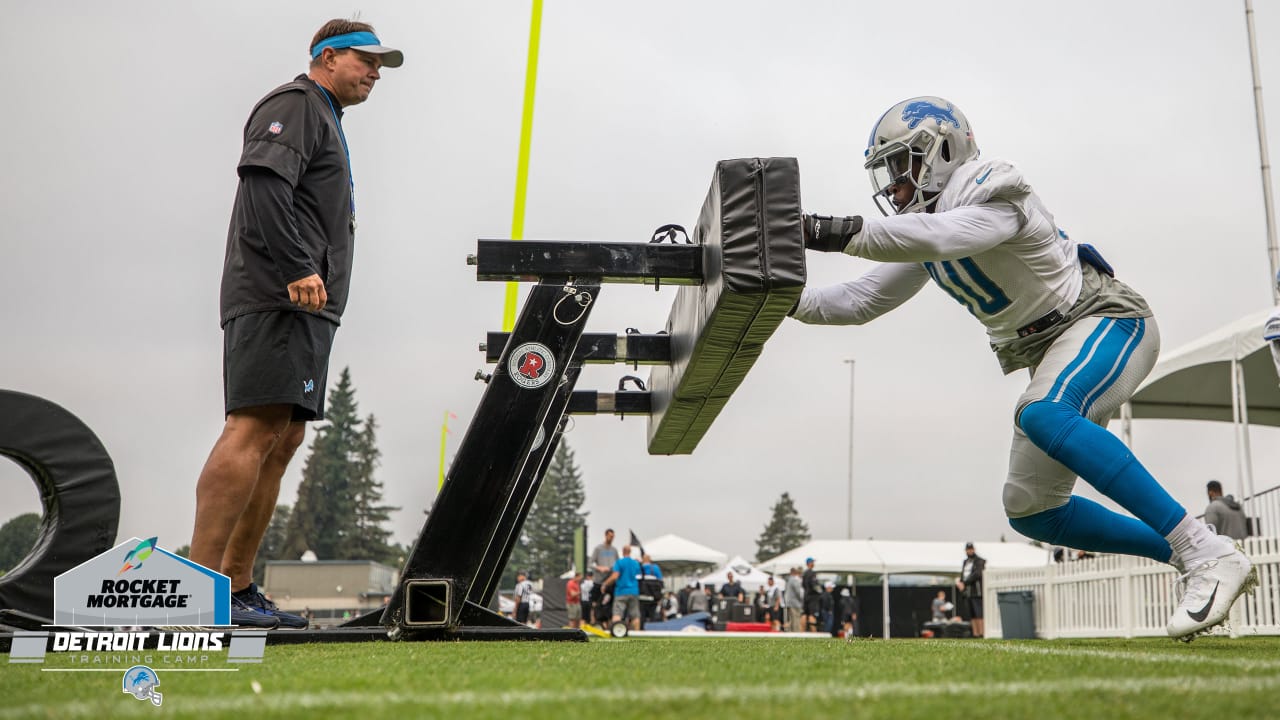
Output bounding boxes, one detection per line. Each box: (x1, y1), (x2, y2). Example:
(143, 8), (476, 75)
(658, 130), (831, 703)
(1129, 304), (1280, 425)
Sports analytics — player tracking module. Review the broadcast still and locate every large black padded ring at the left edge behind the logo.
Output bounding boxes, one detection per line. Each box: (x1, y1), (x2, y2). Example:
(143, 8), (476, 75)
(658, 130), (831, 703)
(0, 389), (120, 619)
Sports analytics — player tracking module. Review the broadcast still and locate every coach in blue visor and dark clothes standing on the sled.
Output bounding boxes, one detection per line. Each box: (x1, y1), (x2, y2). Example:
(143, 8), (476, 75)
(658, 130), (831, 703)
(191, 19), (404, 628)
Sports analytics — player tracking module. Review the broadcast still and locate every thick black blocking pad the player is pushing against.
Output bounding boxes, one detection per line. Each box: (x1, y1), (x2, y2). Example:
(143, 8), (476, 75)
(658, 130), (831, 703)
(649, 158), (805, 455)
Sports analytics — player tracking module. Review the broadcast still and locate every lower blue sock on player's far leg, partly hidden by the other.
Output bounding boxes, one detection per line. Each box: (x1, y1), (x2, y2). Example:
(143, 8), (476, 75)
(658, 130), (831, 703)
(1009, 495), (1172, 562)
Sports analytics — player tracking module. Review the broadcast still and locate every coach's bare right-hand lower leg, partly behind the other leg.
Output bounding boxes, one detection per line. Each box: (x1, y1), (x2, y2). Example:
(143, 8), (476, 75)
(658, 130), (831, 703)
(223, 423), (306, 592)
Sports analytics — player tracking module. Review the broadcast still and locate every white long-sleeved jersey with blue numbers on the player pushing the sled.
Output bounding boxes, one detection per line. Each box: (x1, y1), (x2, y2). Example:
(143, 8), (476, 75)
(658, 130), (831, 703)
(795, 160), (1083, 345)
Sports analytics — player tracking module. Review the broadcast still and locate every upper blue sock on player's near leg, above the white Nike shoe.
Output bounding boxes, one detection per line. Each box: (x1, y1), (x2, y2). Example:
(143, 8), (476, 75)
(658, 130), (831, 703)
(1018, 400), (1187, 535)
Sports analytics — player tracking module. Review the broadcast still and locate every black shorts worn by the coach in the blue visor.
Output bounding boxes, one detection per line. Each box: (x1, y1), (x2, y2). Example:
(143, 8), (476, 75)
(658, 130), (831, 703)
(223, 310), (338, 421)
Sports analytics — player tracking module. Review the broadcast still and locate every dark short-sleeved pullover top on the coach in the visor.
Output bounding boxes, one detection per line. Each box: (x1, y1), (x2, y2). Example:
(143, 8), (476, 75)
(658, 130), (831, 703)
(220, 76), (356, 325)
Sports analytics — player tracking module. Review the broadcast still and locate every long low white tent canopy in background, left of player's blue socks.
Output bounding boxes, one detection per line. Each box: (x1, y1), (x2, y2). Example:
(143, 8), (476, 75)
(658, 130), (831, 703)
(758, 539), (1052, 575)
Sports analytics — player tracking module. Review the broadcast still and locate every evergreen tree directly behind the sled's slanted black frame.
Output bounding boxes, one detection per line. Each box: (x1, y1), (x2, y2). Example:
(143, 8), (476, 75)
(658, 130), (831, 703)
(502, 439), (586, 587)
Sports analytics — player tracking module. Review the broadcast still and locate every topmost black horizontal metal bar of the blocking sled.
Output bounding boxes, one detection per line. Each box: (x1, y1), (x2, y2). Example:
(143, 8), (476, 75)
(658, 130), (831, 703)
(467, 240), (703, 284)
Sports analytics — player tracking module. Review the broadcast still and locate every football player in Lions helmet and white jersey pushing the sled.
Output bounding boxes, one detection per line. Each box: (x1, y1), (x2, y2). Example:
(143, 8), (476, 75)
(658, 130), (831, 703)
(792, 96), (1257, 641)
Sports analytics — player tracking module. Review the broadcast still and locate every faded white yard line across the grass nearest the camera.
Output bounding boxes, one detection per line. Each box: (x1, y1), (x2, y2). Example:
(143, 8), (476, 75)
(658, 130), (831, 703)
(0, 671), (1280, 720)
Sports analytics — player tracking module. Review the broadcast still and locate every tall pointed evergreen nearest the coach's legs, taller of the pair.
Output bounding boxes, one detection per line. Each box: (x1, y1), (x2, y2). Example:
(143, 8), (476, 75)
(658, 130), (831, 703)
(283, 368), (361, 560)
